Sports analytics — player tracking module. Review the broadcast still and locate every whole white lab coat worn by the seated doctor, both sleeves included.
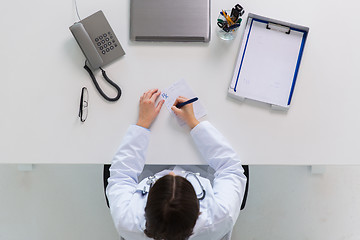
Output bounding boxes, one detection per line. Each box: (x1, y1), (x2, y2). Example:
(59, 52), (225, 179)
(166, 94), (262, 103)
(106, 121), (246, 240)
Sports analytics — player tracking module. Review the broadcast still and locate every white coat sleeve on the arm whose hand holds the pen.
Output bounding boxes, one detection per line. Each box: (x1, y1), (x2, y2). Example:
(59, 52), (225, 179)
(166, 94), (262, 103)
(191, 121), (247, 224)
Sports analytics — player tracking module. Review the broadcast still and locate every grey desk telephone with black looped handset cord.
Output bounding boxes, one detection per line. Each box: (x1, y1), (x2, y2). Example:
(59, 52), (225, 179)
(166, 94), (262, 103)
(70, 11), (125, 102)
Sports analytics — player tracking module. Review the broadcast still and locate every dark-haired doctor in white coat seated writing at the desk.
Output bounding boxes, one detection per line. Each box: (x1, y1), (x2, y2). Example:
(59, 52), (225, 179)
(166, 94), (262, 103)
(106, 89), (247, 240)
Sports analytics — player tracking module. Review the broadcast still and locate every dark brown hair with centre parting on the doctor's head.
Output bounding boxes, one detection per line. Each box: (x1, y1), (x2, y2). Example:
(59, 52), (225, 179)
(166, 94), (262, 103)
(144, 175), (199, 240)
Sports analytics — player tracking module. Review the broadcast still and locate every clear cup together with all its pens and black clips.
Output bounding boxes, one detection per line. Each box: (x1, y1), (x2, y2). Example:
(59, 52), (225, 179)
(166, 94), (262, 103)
(217, 4), (244, 40)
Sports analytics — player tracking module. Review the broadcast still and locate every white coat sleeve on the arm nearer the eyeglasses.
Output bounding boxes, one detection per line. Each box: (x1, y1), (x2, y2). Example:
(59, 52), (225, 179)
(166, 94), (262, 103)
(106, 125), (150, 232)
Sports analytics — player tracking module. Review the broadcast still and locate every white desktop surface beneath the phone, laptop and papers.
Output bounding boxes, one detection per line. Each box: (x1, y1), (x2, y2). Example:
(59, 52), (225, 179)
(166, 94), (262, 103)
(0, 0), (360, 165)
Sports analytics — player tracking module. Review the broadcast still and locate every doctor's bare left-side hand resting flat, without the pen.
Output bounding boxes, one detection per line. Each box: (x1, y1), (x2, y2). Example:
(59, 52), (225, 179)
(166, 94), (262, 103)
(136, 89), (164, 128)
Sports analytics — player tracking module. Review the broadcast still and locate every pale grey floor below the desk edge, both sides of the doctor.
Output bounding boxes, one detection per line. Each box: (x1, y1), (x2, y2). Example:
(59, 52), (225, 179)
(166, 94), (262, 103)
(0, 165), (360, 240)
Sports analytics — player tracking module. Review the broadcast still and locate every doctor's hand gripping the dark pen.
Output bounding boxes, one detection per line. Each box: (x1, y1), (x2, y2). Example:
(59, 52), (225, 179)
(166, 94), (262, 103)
(171, 96), (200, 129)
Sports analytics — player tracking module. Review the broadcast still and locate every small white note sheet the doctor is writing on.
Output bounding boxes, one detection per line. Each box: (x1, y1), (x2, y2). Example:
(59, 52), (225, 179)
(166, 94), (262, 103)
(160, 80), (206, 126)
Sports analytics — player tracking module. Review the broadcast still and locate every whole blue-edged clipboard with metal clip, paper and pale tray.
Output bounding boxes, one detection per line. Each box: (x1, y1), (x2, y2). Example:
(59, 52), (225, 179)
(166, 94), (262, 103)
(228, 13), (309, 110)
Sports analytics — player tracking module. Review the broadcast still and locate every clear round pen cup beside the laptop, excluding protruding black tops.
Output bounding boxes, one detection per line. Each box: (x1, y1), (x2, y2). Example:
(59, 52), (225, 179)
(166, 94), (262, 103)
(216, 10), (242, 40)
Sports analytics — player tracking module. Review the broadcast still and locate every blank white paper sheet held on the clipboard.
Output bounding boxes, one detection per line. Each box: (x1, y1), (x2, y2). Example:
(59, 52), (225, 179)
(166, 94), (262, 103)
(231, 20), (303, 107)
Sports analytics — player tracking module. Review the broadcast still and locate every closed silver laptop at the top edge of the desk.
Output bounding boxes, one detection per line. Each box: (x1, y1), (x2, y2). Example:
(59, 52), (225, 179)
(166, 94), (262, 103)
(130, 0), (210, 42)
